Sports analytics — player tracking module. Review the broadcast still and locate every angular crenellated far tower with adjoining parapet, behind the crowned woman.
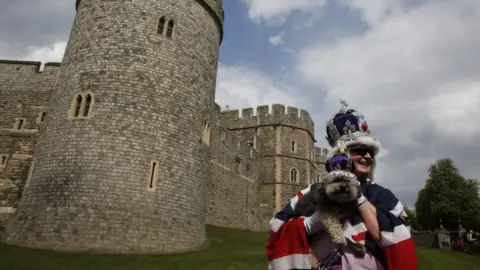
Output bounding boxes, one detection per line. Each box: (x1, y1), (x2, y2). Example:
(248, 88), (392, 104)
(220, 104), (323, 220)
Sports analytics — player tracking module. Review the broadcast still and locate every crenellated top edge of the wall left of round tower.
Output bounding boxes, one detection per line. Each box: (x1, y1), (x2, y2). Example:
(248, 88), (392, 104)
(0, 59), (61, 74)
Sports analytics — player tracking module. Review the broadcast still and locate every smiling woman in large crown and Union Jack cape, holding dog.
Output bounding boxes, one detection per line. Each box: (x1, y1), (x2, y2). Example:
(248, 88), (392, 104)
(267, 105), (418, 270)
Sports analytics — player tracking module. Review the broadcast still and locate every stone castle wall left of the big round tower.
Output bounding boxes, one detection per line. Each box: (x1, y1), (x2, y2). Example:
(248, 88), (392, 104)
(0, 60), (59, 222)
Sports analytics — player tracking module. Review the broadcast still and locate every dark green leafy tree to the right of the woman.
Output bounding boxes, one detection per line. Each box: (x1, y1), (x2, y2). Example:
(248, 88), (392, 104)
(415, 158), (480, 230)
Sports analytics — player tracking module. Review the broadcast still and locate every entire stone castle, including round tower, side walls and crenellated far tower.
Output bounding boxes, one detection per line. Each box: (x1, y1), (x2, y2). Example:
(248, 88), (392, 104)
(0, 0), (327, 253)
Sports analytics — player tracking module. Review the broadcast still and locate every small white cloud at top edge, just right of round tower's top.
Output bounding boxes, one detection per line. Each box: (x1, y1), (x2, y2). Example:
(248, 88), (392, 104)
(242, 0), (327, 24)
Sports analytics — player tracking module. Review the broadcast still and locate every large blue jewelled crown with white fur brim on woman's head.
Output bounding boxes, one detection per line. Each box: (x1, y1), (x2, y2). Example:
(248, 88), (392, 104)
(326, 100), (381, 155)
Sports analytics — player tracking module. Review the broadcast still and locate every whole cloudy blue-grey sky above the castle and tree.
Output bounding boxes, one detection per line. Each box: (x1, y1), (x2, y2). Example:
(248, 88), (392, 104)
(0, 0), (480, 205)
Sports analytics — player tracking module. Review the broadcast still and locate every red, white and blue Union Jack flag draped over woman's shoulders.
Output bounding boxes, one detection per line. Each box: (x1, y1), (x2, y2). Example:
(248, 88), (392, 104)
(267, 182), (418, 270)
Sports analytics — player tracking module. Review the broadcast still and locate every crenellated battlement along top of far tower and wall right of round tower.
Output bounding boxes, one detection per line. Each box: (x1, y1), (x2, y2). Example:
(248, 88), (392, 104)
(220, 104), (314, 136)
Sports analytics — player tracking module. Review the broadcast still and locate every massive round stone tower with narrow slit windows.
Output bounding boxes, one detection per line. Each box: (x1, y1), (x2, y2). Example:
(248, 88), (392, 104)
(5, 0), (223, 253)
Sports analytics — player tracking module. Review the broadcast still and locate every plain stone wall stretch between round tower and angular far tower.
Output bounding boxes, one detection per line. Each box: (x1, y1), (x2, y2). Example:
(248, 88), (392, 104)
(206, 121), (260, 230)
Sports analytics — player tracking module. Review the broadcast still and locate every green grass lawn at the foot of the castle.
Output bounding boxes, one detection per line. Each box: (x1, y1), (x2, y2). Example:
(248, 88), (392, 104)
(0, 227), (480, 270)
